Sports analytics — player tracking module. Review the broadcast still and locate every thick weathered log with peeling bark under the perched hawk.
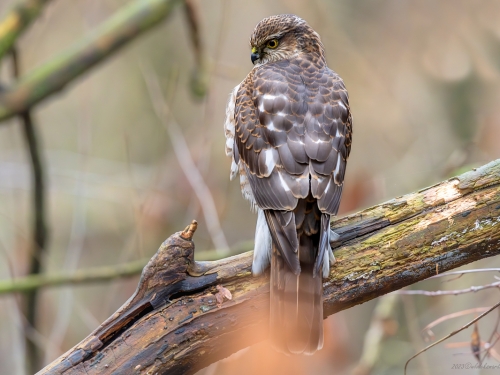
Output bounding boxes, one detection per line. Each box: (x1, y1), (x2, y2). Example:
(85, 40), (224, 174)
(39, 160), (500, 375)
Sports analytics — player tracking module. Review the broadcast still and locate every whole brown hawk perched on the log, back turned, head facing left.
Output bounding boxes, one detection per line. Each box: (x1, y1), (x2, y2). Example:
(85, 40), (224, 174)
(224, 14), (352, 354)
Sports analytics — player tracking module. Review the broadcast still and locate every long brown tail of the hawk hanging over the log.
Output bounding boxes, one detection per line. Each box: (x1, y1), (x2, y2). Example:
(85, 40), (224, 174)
(264, 196), (331, 354)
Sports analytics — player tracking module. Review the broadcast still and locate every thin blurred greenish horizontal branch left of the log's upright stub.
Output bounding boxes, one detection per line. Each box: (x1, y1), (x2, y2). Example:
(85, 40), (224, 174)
(0, 259), (148, 295)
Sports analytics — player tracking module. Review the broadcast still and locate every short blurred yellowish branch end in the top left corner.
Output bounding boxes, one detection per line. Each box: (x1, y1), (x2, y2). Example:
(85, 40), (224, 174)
(0, 0), (50, 59)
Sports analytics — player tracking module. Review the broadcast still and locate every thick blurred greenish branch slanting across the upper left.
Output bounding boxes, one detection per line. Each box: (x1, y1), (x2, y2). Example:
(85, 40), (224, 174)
(0, 0), (180, 120)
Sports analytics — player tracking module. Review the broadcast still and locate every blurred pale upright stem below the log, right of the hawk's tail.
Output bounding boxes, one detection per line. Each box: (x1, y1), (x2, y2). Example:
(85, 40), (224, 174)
(352, 293), (398, 375)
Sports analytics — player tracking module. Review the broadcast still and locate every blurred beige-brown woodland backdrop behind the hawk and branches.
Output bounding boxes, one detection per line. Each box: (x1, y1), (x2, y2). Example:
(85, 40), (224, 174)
(0, 0), (500, 375)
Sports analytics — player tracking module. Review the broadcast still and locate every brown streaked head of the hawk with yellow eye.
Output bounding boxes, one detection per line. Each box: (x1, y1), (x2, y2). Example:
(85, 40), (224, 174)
(250, 14), (324, 65)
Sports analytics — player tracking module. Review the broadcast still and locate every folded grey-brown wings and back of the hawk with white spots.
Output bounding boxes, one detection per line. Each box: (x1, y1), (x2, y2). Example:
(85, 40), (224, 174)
(233, 58), (352, 276)
